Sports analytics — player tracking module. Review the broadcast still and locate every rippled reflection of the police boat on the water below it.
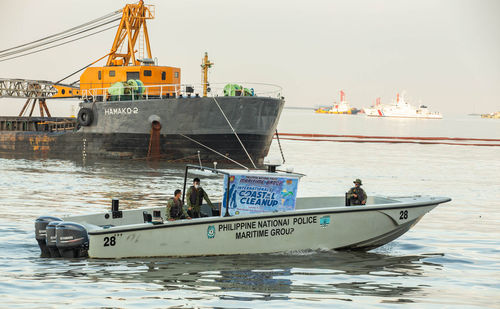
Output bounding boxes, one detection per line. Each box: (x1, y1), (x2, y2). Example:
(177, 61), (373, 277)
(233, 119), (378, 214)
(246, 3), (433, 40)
(24, 251), (442, 299)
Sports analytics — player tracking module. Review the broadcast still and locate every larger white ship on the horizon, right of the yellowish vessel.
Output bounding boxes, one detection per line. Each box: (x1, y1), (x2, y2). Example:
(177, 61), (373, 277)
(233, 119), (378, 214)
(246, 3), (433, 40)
(364, 93), (443, 119)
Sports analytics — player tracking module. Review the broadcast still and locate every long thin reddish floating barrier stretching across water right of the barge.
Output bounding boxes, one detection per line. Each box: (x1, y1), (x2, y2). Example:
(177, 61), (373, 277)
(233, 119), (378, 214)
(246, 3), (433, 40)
(275, 133), (500, 147)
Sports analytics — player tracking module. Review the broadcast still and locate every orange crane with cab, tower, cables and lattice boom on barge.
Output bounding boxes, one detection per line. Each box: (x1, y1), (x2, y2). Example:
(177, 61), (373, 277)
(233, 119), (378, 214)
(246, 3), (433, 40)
(0, 0), (181, 117)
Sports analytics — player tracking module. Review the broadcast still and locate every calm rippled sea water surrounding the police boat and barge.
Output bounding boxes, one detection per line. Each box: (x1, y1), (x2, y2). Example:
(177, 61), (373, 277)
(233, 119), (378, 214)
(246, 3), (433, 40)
(0, 110), (500, 308)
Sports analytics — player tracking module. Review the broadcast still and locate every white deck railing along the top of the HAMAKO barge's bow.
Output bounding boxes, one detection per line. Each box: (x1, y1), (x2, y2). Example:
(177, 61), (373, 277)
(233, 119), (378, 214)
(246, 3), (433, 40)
(81, 82), (282, 102)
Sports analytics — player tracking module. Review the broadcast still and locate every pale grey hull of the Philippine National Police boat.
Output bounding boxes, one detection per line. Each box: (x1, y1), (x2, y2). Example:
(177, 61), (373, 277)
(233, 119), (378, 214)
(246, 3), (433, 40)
(38, 196), (450, 258)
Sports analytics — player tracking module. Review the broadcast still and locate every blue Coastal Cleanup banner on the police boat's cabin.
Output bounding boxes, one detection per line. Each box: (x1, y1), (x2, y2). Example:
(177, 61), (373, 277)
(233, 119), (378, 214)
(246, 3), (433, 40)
(221, 175), (299, 216)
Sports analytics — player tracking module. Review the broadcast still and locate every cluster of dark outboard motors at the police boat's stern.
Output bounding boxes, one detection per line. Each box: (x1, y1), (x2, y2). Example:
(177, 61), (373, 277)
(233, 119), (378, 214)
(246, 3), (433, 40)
(35, 216), (89, 258)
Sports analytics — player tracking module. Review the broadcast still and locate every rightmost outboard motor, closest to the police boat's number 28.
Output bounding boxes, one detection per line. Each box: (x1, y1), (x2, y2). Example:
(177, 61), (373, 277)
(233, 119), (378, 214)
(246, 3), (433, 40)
(56, 222), (89, 258)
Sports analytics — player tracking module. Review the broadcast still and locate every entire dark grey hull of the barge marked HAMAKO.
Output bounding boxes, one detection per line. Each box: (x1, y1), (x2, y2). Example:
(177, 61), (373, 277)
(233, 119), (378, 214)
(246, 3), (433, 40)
(0, 97), (284, 164)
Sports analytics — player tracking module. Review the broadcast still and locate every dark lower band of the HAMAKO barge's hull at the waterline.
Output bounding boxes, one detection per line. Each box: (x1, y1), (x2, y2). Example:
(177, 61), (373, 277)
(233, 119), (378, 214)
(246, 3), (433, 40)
(0, 132), (273, 164)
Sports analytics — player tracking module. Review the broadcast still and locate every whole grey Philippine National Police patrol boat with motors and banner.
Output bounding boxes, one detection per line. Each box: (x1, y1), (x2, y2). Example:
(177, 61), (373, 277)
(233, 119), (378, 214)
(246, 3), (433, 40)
(35, 165), (451, 259)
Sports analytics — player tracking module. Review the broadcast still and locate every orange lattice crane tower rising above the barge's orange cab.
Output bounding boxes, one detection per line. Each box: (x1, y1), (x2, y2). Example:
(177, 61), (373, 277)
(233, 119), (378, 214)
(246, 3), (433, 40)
(106, 0), (154, 66)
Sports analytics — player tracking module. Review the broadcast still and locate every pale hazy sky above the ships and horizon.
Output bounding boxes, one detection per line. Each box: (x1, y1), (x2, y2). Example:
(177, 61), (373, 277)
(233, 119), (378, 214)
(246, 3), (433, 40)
(0, 0), (500, 115)
